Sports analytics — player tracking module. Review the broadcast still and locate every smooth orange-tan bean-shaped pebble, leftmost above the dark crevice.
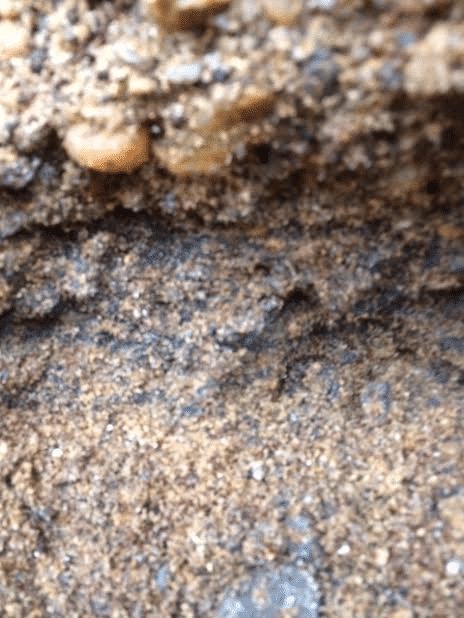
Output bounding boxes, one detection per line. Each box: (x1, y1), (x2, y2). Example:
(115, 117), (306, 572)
(64, 122), (150, 174)
